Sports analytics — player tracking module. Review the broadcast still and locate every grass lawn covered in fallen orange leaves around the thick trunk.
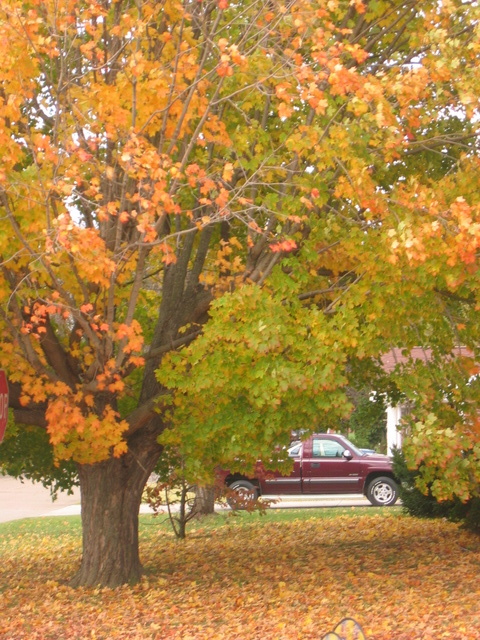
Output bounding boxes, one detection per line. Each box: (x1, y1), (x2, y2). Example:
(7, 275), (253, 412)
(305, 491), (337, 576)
(0, 512), (480, 640)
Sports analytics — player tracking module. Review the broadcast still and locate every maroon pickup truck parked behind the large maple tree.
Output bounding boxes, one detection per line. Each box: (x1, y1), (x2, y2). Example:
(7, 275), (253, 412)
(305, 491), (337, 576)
(225, 433), (398, 507)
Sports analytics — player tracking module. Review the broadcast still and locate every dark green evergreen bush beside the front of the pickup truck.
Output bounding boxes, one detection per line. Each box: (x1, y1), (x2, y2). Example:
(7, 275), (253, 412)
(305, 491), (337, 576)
(393, 449), (480, 533)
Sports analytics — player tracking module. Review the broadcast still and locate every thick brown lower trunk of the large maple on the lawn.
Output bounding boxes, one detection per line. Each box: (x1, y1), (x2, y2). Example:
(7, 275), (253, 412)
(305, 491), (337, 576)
(71, 453), (154, 588)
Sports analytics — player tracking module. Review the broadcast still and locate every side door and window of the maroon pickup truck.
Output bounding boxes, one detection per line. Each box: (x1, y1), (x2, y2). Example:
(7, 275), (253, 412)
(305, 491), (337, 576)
(302, 436), (361, 494)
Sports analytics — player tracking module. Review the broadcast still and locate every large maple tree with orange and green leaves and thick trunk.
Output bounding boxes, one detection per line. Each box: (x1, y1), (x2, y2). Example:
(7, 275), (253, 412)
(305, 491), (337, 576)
(0, 0), (480, 586)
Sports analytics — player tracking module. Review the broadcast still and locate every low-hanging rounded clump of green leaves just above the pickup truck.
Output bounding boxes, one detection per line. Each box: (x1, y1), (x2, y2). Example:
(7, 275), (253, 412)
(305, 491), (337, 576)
(157, 286), (358, 480)
